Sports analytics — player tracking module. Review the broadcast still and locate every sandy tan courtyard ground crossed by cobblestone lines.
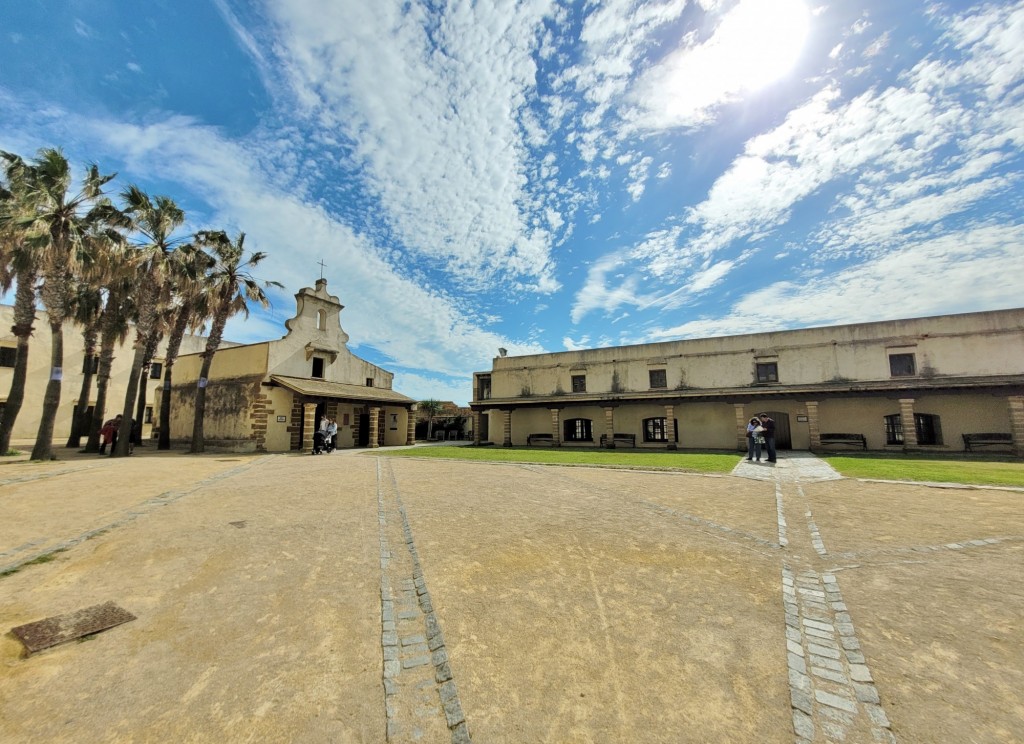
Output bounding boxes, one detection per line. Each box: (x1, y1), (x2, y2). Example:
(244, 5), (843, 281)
(0, 452), (1024, 744)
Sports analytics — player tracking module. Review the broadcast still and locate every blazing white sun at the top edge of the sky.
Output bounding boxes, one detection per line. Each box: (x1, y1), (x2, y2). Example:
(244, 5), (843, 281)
(707, 0), (810, 90)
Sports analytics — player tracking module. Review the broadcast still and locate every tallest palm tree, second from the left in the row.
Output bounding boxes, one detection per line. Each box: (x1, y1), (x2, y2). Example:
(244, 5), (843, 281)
(15, 147), (119, 459)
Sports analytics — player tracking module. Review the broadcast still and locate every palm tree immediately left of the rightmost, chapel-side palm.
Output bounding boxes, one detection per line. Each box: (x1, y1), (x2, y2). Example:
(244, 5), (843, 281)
(157, 245), (213, 449)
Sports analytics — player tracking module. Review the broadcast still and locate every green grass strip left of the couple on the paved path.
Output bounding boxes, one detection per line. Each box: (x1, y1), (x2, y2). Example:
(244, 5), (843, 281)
(373, 447), (740, 473)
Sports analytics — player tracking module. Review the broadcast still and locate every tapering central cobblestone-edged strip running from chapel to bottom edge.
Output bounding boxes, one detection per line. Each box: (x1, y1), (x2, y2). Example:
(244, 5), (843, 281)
(377, 457), (471, 744)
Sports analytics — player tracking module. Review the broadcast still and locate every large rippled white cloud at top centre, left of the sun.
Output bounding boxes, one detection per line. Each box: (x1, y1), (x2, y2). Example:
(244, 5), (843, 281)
(256, 0), (557, 292)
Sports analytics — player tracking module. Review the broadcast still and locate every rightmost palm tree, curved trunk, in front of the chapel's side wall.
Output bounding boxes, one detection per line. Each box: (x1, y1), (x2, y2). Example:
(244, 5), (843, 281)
(190, 232), (283, 452)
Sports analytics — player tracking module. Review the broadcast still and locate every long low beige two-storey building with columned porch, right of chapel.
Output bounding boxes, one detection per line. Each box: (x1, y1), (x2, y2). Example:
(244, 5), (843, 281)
(471, 308), (1024, 456)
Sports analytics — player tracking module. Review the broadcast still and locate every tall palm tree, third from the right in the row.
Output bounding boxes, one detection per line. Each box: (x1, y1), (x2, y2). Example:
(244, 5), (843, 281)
(112, 185), (185, 456)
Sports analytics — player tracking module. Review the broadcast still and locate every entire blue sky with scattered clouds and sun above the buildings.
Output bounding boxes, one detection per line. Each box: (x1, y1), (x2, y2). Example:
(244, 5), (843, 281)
(0, 0), (1024, 403)
